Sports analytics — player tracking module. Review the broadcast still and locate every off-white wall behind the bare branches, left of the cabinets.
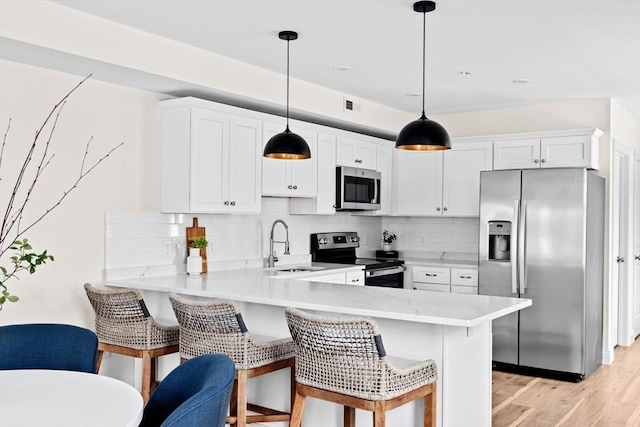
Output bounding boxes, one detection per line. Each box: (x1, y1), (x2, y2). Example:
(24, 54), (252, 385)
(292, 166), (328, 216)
(0, 61), (160, 326)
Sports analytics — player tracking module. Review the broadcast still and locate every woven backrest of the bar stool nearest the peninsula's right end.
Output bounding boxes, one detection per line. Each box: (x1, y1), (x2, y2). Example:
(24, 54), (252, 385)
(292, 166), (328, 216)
(285, 308), (386, 395)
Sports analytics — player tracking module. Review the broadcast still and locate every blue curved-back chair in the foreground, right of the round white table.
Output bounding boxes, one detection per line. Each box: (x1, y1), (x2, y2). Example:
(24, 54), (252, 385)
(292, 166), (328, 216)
(140, 354), (236, 427)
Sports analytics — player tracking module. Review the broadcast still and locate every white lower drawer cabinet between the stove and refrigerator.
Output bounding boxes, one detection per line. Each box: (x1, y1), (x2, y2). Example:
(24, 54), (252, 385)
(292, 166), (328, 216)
(412, 265), (478, 294)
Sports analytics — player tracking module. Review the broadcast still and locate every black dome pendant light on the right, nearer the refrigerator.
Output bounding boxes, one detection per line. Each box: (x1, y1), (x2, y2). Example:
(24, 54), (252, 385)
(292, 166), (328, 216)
(396, 1), (451, 150)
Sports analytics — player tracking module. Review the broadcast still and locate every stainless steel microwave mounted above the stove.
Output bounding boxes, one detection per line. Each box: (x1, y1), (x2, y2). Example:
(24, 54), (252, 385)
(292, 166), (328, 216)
(336, 166), (382, 211)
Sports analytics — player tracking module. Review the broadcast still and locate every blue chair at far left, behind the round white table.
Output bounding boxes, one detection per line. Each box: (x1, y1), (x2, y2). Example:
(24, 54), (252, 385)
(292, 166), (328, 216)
(0, 323), (98, 373)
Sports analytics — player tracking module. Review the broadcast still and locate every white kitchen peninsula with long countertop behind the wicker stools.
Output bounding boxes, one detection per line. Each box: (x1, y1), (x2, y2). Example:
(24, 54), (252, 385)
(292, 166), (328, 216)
(107, 265), (531, 427)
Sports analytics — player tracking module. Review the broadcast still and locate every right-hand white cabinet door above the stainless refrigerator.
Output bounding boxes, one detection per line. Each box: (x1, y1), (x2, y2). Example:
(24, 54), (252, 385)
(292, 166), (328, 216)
(540, 135), (594, 168)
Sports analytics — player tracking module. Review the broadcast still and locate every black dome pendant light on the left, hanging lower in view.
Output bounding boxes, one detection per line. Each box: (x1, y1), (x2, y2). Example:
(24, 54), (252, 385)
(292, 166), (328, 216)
(263, 31), (311, 160)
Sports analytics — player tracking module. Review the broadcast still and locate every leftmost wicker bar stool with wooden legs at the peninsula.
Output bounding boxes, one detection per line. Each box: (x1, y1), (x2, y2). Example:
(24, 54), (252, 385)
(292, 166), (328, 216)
(84, 283), (180, 405)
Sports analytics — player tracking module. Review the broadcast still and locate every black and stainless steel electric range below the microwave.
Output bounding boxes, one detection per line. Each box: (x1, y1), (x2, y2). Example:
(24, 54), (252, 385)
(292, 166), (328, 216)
(310, 232), (404, 288)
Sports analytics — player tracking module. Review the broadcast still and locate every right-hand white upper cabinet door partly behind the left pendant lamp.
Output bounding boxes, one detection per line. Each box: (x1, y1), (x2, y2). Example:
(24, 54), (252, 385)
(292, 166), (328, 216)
(290, 124), (318, 197)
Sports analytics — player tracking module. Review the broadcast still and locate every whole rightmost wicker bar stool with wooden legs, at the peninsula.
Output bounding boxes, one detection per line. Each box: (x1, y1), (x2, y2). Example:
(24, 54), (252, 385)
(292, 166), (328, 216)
(285, 308), (438, 427)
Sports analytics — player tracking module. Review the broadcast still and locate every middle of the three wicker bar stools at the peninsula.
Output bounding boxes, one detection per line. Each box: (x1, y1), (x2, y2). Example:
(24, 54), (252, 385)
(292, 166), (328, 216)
(169, 294), (295, 427)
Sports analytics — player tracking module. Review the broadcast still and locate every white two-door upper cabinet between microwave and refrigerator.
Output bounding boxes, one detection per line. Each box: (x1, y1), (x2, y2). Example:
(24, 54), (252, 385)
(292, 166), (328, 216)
(393, 141), (493, 216)
